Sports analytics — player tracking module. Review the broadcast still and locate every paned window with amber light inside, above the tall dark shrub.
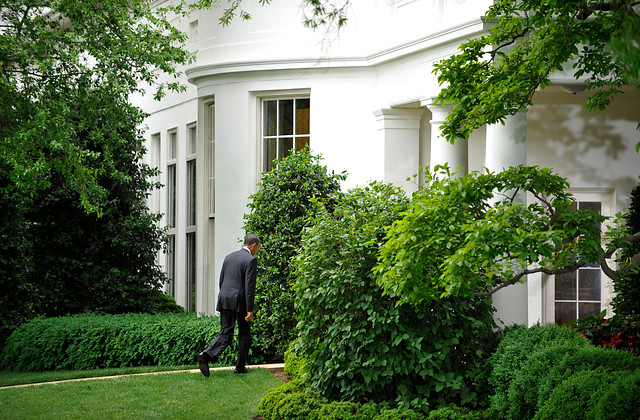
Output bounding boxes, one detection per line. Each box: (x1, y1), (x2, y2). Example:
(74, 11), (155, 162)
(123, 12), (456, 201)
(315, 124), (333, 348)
(262, 98), (311, 171)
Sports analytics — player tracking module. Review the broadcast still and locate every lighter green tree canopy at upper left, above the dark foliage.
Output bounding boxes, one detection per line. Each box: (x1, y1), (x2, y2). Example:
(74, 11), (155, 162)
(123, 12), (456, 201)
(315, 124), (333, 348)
(0, 0), (191, 213)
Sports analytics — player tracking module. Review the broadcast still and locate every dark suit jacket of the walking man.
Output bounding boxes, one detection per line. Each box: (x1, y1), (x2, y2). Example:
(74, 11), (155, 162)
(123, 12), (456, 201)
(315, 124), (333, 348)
(216, 248), (258, 316)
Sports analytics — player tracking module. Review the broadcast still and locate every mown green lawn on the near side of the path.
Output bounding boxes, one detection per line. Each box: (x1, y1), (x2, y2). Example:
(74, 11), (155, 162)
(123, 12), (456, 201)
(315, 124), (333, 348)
(0, 368), (281, 420)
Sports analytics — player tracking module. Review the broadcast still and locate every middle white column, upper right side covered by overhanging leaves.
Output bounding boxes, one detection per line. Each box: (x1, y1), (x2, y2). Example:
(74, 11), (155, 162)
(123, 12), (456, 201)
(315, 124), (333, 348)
(422, 98), (469, 176)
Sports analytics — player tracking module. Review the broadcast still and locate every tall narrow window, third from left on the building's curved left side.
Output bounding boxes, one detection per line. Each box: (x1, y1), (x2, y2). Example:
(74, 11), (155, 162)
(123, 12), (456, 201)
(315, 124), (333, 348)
(185, 124), (198, 311)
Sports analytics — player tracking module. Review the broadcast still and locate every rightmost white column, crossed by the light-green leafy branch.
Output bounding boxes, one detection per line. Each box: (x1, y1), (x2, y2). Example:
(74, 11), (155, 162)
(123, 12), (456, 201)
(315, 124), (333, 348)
(485, 112), (528, 325)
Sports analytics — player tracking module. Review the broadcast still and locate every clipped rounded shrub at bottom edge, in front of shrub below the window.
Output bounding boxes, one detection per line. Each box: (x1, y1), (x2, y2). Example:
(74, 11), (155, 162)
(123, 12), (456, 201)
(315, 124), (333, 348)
(534, 368), (608, 420)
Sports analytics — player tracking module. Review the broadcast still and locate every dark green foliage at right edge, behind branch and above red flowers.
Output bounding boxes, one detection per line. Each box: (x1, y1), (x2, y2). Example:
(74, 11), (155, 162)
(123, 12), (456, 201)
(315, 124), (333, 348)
(612, 180), (640, 316)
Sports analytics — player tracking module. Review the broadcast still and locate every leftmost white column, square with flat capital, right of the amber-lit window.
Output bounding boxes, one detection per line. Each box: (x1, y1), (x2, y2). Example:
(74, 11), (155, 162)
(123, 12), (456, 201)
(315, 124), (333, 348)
(374, 108), (424, 194)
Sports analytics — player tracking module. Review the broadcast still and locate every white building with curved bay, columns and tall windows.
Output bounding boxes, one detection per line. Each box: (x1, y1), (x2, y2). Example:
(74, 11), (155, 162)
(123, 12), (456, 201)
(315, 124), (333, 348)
(135, 0), (640, 324)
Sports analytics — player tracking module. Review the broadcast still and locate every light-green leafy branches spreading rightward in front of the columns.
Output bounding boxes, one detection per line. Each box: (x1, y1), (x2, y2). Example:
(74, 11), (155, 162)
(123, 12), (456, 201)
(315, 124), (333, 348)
(375, 166), (640, 303)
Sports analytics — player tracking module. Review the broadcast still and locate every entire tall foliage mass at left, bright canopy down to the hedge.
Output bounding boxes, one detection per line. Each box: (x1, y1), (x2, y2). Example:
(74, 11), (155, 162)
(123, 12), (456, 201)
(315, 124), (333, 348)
(0, 0), (191, 341)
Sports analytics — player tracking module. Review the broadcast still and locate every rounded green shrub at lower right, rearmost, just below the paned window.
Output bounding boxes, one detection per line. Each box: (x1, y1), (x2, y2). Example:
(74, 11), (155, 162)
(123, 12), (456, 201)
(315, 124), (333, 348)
(489, 324), (589, 418)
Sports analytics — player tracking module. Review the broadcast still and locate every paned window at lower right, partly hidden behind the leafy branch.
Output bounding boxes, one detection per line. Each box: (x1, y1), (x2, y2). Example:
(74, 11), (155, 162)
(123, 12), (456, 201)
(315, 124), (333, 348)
(554, 201), (602, 325)
